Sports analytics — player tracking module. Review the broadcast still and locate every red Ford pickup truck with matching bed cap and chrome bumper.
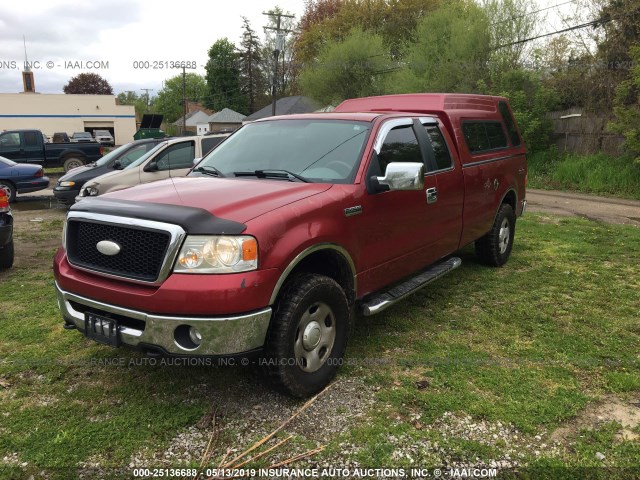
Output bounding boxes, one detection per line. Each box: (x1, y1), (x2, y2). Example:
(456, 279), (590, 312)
(54, 94), (527, 396)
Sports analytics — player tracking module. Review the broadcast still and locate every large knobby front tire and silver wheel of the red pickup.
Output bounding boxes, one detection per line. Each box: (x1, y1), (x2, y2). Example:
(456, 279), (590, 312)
(262, 274), (350, 398)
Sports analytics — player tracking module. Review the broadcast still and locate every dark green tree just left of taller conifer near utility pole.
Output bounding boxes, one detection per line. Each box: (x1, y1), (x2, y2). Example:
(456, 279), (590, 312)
(204, 38), (249, 114)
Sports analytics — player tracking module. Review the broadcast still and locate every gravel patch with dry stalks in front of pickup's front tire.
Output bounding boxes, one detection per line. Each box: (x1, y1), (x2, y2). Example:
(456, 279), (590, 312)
(83, 378), (375, 469)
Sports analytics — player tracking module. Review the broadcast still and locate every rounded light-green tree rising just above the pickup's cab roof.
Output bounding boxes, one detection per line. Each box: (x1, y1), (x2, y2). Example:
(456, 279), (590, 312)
(300, 28), (394, 105)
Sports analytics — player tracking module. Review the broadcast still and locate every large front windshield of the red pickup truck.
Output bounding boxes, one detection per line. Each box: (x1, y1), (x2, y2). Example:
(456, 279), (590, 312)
(189, 119), (371, 183)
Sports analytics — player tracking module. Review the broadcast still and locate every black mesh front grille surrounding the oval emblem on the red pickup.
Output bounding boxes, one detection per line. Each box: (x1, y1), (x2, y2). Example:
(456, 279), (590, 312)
(66, 219), (171, 282)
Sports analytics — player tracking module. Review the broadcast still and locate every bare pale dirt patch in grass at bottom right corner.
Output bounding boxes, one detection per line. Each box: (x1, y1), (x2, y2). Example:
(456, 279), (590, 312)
(550, 396), (640, 443)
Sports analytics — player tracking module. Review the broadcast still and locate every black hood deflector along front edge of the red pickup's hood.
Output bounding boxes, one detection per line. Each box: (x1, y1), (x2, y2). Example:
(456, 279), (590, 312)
(71, 197), (247, 235)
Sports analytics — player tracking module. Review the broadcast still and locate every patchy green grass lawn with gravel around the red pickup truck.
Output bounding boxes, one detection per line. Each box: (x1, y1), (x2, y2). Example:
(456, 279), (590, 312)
(0, 215), (640, 478)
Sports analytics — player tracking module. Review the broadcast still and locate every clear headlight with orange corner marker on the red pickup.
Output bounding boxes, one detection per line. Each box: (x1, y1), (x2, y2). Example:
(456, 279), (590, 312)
(173, 235), (258, 273)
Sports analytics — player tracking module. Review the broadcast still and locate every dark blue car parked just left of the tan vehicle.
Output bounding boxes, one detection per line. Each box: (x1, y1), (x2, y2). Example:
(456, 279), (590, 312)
(53, 138), (164, 205)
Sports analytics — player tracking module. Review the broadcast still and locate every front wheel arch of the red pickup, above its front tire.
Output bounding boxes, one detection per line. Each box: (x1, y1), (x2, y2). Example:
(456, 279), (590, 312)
(269, 243), (357, 305)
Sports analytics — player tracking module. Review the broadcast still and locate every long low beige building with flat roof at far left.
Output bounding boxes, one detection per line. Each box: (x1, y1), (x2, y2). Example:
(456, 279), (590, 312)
(0, 93), (136, 145)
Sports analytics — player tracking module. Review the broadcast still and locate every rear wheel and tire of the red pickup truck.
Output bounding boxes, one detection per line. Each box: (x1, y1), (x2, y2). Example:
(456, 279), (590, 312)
(475, 203), (516, 267)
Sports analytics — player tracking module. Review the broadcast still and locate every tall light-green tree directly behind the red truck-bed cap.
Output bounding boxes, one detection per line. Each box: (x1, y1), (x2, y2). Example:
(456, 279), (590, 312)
(391, 1), (490, 93)
